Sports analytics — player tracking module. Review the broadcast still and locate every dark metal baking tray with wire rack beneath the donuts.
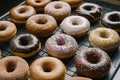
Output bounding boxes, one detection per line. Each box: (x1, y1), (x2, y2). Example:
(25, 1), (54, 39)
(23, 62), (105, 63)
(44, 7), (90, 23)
(0, 0), (120, 80)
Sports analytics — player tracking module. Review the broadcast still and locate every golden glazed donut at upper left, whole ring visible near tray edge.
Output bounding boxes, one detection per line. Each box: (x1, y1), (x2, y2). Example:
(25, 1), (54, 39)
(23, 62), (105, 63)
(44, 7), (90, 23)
(10, 5), (36, 24)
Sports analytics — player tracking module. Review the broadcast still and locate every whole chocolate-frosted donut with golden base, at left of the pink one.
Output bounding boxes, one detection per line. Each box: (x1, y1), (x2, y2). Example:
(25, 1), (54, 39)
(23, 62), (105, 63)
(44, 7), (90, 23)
(10, 33), (41, 58)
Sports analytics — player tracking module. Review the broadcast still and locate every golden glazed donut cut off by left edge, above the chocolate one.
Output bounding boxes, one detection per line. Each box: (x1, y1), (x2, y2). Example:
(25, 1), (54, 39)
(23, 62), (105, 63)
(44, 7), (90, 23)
(0, 21), (17, 43)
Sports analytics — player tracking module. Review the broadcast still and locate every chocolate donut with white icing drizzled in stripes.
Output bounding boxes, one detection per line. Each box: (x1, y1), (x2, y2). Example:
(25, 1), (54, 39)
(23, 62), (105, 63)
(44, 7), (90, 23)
(76, 3), (102, 22)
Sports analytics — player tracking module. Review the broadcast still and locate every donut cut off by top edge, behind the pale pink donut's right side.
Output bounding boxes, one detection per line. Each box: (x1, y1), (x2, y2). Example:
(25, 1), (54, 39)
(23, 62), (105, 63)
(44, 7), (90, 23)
(59, 0), (83, 9)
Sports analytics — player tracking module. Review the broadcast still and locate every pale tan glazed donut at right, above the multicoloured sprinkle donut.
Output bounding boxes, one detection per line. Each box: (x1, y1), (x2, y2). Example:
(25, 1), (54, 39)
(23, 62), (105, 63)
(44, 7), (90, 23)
(89, 28), (120, 52)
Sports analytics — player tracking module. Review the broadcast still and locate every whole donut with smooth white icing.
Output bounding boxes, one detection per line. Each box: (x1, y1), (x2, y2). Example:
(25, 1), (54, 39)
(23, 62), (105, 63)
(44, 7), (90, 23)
(60, 16), (90, 37)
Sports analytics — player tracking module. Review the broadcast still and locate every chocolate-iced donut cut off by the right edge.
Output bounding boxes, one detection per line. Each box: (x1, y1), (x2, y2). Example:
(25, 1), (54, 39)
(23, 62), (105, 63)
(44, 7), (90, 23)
(100, 11), (120, 32)
